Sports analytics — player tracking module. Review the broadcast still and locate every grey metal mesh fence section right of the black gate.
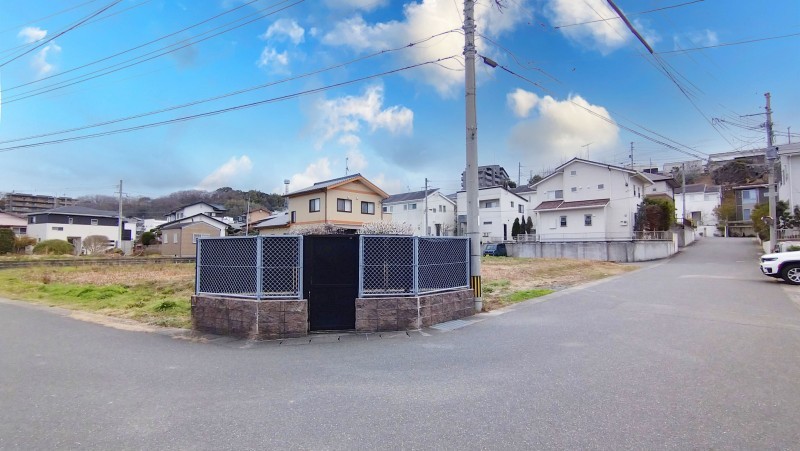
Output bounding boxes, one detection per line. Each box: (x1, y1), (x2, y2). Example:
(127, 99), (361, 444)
(358, 235), (469, 297)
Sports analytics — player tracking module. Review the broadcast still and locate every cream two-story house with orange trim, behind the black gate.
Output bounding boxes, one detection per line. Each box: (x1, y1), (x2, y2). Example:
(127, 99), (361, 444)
(282, 174), (389, 233)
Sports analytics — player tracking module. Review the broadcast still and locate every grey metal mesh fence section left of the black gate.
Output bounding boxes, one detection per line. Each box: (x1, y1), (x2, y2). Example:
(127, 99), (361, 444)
(195, 235), (303, 299)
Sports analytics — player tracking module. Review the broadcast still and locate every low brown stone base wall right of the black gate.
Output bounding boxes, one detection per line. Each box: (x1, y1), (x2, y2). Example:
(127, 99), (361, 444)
(356, 289), (475, 332)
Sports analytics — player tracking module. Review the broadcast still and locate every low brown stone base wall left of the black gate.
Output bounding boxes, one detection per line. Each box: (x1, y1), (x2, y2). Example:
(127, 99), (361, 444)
(192, 295), (308, 340)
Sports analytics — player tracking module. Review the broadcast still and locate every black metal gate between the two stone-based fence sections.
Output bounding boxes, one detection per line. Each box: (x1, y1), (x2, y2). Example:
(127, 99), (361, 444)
(303, 235), (358, 330)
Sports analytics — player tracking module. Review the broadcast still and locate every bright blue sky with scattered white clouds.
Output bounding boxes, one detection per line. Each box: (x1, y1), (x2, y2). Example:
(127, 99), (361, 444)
(0, 0), (800, 197)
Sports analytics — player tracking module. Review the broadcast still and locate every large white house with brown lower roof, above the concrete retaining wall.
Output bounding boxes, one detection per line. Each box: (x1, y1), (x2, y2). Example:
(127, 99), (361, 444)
(534, 158), (652, 241)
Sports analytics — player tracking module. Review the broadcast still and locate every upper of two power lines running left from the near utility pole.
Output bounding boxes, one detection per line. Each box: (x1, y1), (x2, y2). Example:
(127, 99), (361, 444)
(0, 29), (458, 144)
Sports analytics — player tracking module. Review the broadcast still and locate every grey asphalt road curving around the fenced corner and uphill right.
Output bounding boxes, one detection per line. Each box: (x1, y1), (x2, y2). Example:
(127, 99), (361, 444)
(0, 238), (800, 450)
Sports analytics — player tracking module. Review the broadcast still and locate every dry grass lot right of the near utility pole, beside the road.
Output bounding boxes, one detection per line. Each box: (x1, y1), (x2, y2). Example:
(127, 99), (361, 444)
(481, 257), (637, 310)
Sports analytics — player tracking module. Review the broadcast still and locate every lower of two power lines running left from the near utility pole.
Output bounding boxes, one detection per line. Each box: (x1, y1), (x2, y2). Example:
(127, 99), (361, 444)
(0, 55), (458, 152)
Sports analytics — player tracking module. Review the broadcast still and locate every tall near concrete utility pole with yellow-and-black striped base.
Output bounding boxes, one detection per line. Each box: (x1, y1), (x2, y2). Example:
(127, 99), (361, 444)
(464, 0), (483, 312)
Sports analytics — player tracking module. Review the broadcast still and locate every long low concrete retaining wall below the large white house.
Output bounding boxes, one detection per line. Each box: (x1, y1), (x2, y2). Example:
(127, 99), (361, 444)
(507, 240), (678, 263)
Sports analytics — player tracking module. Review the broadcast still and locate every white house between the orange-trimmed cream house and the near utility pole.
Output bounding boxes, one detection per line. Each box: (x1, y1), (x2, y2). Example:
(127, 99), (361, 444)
(383, 188), (456, 236)
